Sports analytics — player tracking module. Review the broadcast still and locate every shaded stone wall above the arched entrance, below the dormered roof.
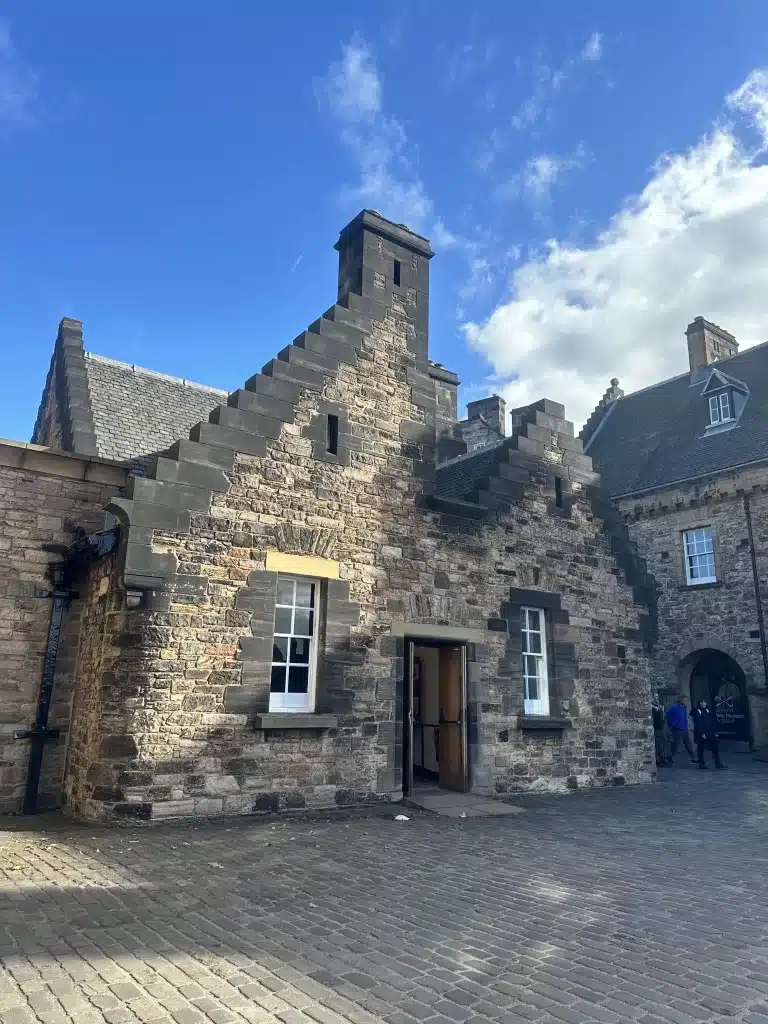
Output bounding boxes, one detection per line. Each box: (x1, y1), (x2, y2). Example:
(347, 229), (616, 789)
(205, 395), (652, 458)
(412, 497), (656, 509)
(620, 468), (768, 745)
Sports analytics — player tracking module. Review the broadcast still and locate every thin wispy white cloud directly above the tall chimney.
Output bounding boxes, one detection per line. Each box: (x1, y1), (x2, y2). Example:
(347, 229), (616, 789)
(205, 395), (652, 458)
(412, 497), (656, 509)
(315, 36), (433, 231)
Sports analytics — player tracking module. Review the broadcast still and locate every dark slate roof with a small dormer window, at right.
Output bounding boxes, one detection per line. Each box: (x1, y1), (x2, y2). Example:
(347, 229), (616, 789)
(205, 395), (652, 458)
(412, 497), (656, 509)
(585, 343), (768, 497)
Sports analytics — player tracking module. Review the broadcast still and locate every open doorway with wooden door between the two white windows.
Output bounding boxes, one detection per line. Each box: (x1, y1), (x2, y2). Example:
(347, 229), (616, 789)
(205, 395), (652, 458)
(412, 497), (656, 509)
(402, 640), (468, 796)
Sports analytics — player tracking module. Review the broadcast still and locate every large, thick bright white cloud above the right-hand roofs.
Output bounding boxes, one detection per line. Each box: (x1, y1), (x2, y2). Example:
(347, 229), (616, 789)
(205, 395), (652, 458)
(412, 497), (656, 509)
(464, 71), (768, 424)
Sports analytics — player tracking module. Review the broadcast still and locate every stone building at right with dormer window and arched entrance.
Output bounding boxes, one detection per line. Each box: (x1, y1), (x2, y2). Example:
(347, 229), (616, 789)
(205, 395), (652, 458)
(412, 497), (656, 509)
(582, 316), (768, 745)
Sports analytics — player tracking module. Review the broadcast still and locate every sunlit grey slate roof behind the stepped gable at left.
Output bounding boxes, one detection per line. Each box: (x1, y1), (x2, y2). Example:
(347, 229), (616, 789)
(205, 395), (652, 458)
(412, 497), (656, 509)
(85, 352), (227, 467)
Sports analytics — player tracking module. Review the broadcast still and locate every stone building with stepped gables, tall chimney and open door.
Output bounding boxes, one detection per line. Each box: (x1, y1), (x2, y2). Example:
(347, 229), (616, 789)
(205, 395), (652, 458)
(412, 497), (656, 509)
(0, 211), (655, 820)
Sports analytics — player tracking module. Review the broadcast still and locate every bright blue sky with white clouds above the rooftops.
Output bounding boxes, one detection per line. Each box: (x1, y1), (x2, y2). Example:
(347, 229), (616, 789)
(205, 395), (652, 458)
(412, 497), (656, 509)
(0, 0), (768, 439)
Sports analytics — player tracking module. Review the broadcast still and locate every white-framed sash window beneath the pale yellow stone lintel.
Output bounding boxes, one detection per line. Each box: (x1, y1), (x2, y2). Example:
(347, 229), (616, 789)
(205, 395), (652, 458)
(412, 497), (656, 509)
(269, 573), (319, 712)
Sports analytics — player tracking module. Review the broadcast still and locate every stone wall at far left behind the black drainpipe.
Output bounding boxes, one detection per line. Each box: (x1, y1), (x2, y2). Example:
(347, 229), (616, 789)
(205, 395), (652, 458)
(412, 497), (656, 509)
(0, 441), (125, 812)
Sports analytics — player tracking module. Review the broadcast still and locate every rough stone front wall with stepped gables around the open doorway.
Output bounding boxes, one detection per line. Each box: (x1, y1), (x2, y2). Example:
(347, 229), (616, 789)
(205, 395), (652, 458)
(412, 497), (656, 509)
(68, 246), (654, 819)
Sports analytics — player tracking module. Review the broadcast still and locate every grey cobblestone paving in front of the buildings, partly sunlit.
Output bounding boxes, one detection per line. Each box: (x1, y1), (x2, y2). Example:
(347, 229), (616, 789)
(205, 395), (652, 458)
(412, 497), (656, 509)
(0, 761), (768, 1024)
